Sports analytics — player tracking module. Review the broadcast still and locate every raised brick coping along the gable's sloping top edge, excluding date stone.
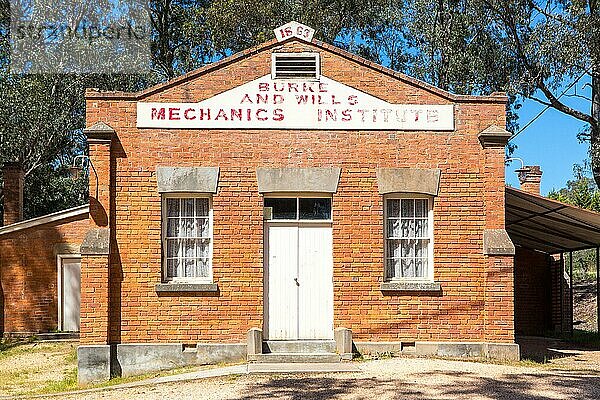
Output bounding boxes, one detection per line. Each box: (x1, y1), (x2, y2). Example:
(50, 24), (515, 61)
(85, 37), (508, 103)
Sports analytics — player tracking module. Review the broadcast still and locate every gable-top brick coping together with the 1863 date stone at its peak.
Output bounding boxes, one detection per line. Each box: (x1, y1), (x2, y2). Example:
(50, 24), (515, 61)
(85, 21), (508, 103)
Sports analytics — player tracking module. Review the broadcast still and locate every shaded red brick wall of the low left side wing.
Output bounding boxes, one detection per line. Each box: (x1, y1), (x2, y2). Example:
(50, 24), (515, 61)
(0, 214), (88, 334)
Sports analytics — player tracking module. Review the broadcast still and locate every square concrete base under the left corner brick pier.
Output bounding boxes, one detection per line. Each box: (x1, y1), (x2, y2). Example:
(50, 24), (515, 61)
(77, 345), (111, 384)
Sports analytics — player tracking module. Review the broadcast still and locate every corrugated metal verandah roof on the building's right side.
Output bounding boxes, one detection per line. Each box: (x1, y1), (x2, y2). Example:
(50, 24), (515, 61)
(506, 187), (600, 254)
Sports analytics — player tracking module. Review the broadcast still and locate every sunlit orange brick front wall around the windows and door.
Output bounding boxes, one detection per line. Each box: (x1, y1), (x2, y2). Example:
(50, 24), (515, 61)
(83, 38), (513, 343)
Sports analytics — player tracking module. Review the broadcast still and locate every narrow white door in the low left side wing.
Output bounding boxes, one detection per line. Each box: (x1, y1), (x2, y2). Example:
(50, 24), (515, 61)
(60, 258), (81, 332)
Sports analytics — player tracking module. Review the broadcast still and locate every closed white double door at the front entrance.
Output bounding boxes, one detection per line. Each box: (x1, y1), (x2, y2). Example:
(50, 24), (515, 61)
(264, 222), (333, 340)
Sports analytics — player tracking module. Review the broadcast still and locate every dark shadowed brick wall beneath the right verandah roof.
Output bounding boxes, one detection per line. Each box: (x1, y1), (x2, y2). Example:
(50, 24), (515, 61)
(515, 247), (552, 336)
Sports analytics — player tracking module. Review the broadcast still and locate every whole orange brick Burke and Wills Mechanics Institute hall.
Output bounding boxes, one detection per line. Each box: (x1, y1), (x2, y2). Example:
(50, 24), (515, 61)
(0, 23), (600, 381)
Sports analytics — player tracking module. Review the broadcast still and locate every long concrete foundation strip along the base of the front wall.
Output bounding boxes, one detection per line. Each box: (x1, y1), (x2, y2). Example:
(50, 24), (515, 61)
(77, 340), (520, 383)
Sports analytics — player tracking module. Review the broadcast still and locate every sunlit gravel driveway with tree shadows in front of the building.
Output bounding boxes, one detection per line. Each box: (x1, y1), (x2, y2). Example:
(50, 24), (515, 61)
(37, 355), (600, 400)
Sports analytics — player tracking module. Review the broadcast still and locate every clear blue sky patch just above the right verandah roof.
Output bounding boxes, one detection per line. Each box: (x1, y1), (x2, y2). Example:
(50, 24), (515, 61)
(506, 79), (589, 195)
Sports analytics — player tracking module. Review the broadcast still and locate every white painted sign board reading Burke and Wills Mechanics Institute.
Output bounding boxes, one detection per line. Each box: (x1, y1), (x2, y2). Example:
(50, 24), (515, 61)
(137, 75), (454, 131)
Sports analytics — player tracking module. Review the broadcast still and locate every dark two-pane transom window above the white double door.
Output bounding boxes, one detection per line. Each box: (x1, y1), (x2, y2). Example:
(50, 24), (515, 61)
(264, 197), (331, 221)
